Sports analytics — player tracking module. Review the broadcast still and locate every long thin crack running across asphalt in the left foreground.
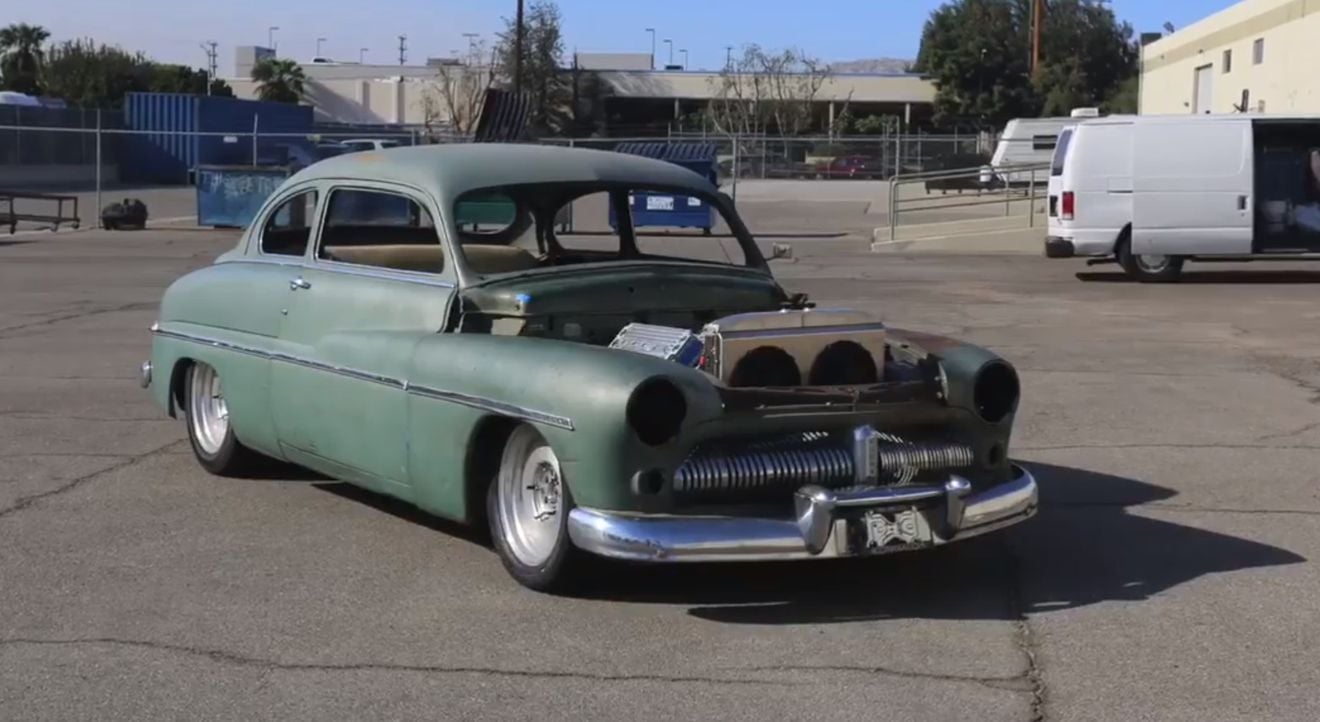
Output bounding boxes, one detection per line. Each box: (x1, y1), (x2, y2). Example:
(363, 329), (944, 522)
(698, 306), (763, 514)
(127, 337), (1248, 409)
(0, 638), (800, 686)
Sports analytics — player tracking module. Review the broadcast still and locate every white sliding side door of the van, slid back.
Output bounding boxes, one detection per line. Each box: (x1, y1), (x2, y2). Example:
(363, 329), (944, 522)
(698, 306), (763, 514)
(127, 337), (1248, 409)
(1131, 117), (1253, 256)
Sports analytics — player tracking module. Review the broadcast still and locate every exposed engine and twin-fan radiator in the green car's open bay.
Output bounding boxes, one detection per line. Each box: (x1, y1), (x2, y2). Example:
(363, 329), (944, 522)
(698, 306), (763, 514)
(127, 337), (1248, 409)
(610, 308), (886, 387)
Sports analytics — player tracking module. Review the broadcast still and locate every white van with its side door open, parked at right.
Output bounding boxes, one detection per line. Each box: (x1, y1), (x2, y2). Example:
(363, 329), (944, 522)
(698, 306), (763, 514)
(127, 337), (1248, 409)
(1045, 115), (1320, 281)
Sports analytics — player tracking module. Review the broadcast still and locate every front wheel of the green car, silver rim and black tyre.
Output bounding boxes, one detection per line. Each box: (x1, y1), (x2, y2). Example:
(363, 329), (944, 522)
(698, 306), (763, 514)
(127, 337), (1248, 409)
(486, 424), (582, 591)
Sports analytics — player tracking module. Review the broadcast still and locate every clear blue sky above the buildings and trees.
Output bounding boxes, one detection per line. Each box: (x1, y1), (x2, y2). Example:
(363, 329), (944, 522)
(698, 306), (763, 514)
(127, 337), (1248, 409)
(15, 0), (1234, 75)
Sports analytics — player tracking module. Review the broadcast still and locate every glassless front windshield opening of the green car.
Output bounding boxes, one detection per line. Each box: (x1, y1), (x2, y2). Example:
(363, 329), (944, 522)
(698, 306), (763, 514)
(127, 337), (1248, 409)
(453, 185), (762, 275)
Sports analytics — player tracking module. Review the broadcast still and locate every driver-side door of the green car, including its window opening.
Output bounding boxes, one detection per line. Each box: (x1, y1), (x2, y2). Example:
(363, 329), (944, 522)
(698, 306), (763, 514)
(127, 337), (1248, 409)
(272, 182), (455, 498)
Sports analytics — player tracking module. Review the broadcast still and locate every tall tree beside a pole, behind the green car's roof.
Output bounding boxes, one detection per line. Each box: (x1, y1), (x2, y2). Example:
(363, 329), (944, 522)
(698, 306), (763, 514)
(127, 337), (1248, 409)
(495, 0), (562, 133)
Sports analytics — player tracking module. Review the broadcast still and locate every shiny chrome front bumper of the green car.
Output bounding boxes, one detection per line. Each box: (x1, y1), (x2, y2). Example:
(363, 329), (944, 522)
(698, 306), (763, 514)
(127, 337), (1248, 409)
(569, 466), (1038, 562)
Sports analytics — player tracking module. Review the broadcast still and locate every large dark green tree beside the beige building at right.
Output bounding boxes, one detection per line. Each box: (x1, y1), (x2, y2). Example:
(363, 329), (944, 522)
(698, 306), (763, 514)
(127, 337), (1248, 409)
(916, 0), (1137, 125)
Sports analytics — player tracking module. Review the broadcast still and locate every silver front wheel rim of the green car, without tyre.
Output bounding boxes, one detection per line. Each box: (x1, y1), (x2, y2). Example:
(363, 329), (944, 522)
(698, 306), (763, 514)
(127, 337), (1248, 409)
(496, 426), (568, 566)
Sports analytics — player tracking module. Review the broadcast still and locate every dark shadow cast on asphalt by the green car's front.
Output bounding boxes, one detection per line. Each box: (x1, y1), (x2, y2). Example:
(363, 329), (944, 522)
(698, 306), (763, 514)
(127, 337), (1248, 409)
(562, 463), (1305, 624)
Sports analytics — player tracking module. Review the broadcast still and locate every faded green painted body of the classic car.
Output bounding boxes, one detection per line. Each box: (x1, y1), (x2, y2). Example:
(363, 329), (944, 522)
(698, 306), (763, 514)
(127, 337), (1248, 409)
(152, 145), (1029, 530)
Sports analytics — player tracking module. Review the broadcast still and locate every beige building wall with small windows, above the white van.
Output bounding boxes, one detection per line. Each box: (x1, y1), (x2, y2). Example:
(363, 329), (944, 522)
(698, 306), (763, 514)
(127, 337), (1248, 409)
(1140, 0), (1320, 115)
